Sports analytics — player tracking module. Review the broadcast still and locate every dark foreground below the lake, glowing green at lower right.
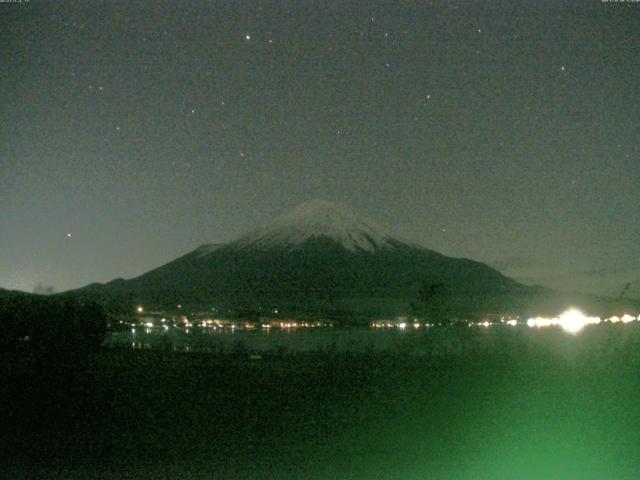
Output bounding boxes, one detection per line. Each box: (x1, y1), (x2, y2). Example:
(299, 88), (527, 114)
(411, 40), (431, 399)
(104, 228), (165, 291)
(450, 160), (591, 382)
(0, 325), (640, 480)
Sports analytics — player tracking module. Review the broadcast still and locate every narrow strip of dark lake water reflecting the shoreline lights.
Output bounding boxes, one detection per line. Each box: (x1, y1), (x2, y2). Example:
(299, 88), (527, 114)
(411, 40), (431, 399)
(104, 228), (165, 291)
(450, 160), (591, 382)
(105, 323), (640, 357)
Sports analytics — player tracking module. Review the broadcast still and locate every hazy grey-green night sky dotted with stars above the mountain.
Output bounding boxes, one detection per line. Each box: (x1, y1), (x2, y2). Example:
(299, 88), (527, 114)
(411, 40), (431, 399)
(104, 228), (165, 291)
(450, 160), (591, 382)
(0, 0), (640, 293)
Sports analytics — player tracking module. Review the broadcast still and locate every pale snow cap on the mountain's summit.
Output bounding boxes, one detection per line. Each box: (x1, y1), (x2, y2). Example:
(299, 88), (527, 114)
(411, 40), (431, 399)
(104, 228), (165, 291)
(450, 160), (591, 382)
(233, 200), (400, 252)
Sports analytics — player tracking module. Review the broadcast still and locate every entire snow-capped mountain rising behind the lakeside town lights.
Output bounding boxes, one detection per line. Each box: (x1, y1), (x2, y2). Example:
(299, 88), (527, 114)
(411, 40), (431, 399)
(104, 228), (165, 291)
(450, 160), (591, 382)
(74, 200), (532, 316)
